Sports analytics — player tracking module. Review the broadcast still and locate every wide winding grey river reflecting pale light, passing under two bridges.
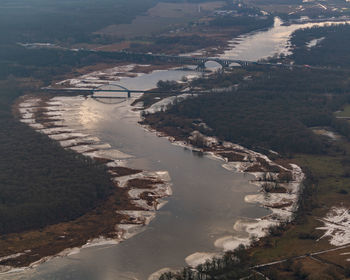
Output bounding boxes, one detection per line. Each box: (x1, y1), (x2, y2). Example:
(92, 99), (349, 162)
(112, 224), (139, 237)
(4, 19), (348, 280)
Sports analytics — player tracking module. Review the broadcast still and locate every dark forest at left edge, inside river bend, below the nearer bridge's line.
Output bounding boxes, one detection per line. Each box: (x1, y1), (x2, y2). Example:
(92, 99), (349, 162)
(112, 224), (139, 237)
(0, 81), (113, 234)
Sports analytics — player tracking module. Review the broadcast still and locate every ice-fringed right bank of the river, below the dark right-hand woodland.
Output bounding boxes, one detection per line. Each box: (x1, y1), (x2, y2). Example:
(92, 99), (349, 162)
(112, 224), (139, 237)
(141, 110), (304, 260)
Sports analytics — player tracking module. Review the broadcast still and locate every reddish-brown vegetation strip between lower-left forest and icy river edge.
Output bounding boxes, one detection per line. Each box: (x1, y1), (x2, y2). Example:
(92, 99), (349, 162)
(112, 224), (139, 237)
(0, 182), (141, 267)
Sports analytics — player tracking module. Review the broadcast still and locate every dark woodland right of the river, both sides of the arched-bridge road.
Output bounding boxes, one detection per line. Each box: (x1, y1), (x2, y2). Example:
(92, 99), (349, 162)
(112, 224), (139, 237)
(147, 25), (350, 154)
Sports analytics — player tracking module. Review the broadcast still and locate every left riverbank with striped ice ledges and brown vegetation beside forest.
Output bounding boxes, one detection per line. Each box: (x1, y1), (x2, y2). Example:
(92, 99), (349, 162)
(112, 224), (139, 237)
(0, 95), (172, 273)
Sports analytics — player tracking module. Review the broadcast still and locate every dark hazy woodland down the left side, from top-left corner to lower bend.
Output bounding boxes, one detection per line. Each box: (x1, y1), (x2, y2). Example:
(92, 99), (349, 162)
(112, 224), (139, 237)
(0, 0), (152, 234)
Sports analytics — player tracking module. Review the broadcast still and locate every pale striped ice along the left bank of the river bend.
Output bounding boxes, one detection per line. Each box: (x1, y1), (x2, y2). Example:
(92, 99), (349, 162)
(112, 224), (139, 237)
(14, 94), (172, 272)
